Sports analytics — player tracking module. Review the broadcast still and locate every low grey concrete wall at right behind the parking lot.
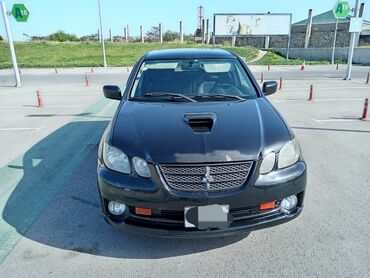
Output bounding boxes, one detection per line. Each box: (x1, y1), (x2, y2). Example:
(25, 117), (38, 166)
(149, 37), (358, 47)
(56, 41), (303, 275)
(273, 47), (370, 65)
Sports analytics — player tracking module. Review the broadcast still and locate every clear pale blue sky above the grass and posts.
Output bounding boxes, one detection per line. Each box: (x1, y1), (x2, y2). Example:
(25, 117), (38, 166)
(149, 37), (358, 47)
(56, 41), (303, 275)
(0, 0), (370, 40)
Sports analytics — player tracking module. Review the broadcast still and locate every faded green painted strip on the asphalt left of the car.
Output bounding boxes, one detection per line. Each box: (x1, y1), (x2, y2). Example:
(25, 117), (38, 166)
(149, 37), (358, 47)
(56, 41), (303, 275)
(0, 99), (117, 264)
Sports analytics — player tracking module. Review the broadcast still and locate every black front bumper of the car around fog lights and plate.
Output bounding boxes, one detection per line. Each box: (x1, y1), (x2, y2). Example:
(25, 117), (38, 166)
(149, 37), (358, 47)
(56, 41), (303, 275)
(98, 161), (307, 238)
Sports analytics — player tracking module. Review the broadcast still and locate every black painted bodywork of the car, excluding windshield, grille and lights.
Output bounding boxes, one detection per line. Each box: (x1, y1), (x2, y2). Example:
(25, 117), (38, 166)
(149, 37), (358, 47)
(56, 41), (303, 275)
(97, 49), (307, 237)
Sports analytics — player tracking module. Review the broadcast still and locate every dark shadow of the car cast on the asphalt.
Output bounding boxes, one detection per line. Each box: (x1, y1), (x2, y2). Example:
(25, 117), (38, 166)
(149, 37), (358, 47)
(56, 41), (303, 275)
(2, 121), (245, 259)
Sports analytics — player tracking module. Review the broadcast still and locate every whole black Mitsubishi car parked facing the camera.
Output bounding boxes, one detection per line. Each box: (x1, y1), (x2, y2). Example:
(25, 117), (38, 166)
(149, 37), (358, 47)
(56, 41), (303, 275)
(97, 49), (307, 237)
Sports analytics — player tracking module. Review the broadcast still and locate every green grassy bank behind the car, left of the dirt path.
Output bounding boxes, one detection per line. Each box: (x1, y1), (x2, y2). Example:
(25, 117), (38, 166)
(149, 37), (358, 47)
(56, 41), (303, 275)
(0, 42), (258, 68)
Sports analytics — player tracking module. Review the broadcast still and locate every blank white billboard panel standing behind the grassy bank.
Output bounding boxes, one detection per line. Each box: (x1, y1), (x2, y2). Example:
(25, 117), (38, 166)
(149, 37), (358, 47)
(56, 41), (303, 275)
(214, 14), (292, 36)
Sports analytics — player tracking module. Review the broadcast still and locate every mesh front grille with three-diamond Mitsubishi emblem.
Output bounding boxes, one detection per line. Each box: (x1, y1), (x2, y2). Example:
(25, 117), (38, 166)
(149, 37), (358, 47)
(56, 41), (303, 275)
(159, 161), (252, 192)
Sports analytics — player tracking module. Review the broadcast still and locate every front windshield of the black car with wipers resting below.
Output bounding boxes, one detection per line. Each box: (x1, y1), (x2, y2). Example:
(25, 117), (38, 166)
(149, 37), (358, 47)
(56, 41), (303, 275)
(130, 59), (257, 101)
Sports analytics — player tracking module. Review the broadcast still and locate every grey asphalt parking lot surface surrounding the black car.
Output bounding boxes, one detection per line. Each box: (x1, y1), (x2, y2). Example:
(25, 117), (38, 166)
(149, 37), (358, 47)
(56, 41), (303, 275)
(0, 66), (370, 277)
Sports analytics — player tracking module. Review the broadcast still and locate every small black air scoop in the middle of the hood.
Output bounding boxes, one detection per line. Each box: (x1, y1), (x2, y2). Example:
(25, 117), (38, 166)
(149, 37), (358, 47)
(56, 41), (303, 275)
(184, 113), (216, 133)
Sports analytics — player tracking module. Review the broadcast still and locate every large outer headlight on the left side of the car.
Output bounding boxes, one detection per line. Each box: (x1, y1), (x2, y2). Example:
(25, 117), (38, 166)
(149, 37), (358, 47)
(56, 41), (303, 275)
(103, 143), (131, 174)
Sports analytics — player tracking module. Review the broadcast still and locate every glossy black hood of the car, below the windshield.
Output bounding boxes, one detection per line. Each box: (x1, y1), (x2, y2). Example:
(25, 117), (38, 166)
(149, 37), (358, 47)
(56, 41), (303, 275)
(111, 98), (292, 163)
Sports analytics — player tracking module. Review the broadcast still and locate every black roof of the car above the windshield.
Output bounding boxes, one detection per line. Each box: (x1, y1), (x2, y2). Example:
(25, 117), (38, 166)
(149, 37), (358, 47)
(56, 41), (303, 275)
(144, 48), (236, 60)
